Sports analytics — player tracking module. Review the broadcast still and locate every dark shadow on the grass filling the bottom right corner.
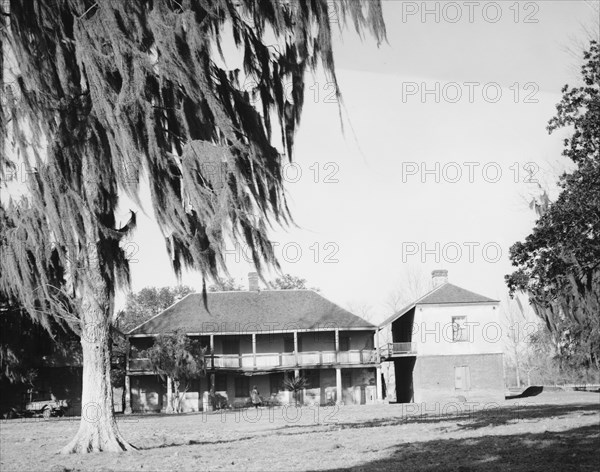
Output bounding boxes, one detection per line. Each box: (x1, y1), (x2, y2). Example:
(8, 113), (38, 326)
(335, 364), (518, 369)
(316, 425), (600, 472)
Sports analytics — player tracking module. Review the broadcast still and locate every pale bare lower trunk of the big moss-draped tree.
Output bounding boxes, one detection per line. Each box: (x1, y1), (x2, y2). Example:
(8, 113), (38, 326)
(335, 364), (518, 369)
(60, 281), (135, 454)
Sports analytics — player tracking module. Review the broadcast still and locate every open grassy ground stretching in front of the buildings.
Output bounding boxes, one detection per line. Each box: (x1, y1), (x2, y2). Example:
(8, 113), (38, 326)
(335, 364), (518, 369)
(0, 392), (600, 472)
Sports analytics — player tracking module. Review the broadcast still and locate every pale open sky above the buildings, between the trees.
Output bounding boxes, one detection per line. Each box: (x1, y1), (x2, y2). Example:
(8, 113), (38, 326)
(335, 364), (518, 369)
(4, 0), (598, 320)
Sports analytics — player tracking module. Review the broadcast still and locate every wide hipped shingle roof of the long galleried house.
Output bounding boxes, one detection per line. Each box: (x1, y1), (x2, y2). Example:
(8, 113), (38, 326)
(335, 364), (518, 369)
(128, 290), (375, 335)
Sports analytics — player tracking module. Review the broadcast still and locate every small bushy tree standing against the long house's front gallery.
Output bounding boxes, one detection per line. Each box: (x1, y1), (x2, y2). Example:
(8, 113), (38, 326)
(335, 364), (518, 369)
(145, 333), (206, 413)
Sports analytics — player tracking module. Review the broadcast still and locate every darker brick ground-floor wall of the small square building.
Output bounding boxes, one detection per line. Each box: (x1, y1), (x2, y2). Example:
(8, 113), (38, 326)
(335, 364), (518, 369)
(413, 354), (504, 403)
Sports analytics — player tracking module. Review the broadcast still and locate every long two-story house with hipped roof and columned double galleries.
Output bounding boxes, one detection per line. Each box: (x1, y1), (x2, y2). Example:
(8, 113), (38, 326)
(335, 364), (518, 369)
(126, 274), (381, 412)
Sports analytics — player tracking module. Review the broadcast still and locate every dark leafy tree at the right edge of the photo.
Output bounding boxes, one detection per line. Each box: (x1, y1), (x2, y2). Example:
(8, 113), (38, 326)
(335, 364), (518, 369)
(506, 41), (600, 376)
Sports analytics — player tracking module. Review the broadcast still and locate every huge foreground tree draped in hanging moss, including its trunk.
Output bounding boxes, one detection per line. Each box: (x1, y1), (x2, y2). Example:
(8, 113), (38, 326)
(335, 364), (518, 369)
(0, 0), (385, 453)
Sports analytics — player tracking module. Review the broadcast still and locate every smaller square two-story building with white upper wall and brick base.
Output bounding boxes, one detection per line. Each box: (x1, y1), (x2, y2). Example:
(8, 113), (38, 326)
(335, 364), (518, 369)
(377, 270), (504, 403)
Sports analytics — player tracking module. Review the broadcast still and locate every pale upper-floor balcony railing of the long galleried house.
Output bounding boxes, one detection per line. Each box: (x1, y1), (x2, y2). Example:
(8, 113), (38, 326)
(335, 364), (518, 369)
(129, 349), (377, 372)
